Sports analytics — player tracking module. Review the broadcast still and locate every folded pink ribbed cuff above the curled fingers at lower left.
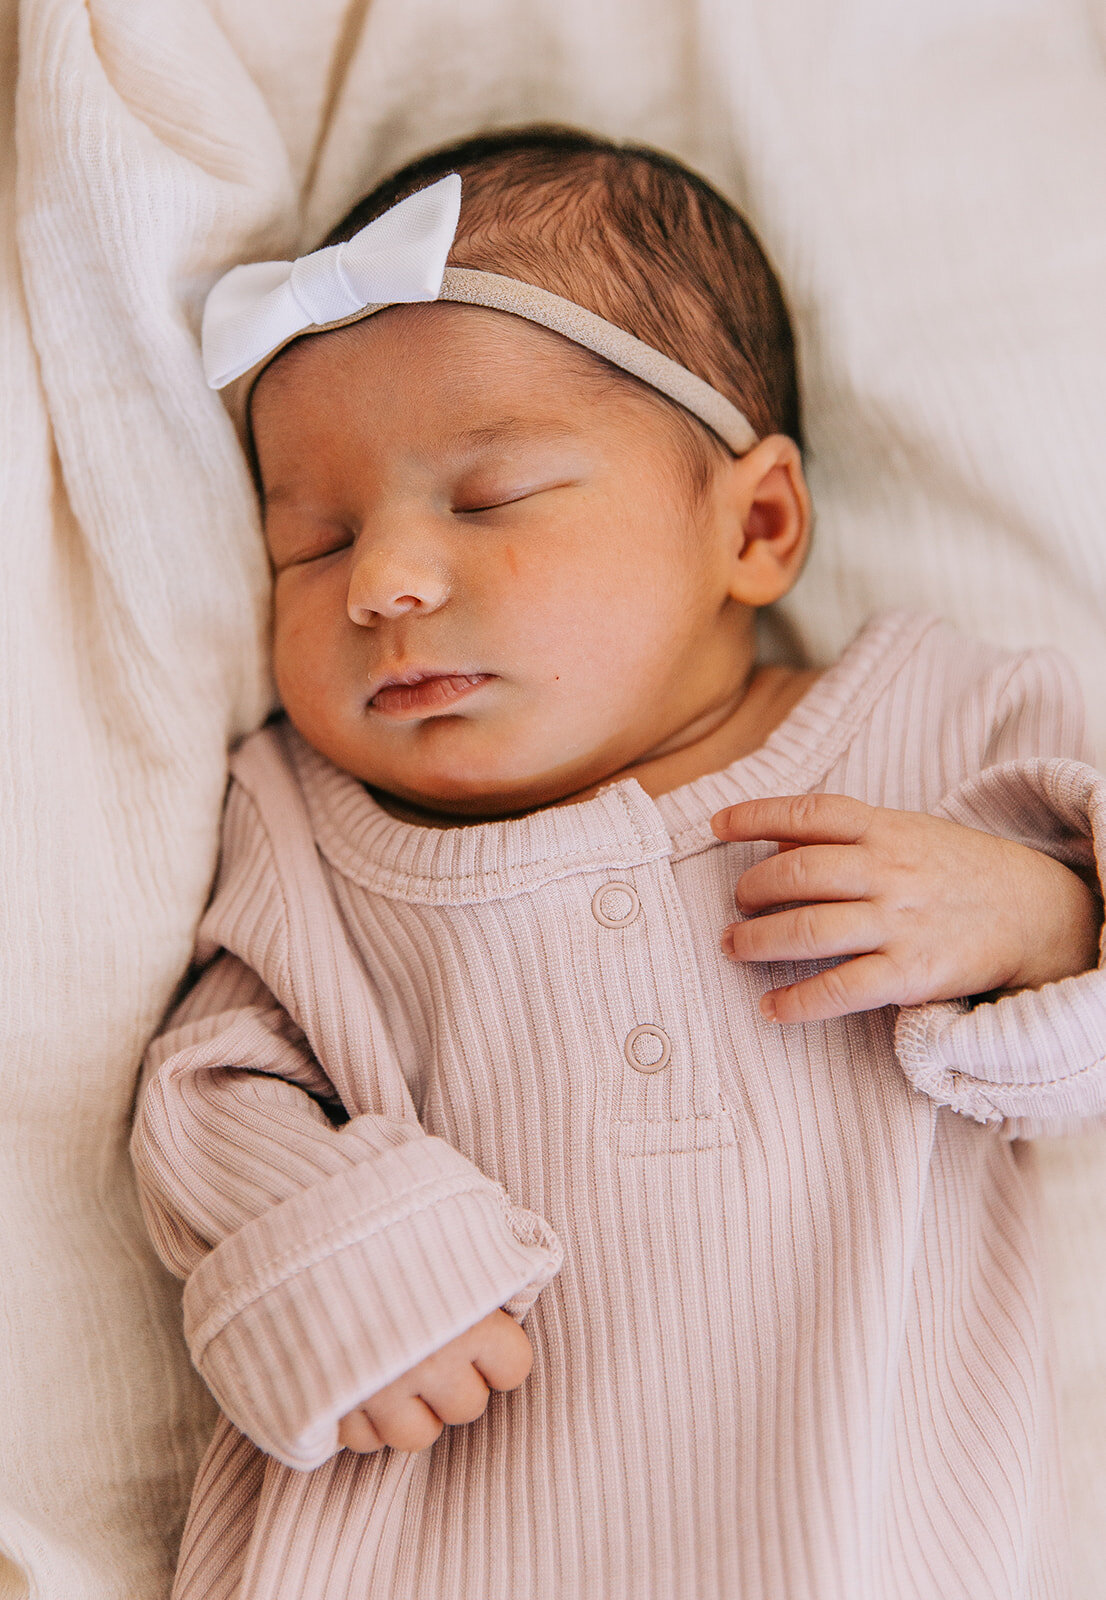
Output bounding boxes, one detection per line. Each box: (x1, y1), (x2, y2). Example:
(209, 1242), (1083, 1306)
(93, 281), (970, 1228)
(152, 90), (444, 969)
(184, 1138), (562, 1469)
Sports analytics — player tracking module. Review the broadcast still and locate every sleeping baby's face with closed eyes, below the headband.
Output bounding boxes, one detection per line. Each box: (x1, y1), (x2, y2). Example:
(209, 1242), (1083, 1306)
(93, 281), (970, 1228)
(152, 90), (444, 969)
(253, 306), (771, 818)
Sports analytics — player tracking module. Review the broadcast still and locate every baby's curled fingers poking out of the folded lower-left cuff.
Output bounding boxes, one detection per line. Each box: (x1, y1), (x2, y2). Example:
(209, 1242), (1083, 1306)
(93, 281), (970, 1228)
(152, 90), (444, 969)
(338, 1310), (533, 1454)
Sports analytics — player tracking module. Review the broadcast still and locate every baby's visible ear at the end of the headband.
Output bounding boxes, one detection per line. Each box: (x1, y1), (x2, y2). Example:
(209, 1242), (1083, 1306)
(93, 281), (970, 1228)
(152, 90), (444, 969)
(723, 434), (810, 606)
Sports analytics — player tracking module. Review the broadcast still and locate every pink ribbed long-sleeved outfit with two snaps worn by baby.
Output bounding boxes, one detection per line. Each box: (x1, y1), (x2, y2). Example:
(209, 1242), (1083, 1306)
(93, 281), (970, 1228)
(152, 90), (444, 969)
(134, 613), (1106, 1600)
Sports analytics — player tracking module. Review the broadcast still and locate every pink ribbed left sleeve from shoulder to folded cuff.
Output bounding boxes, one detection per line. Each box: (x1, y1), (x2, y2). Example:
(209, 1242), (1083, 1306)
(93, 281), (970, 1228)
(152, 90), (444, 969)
(131, 762), (560, 1469)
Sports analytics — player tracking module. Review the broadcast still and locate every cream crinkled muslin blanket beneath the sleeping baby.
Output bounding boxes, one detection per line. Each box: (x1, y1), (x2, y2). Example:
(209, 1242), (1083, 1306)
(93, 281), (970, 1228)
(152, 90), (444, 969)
(0, 0), (1106, 1600)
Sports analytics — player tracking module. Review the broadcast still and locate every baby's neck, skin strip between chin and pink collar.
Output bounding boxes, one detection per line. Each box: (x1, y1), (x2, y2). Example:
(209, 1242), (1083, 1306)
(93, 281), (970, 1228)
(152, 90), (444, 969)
(373, 667), (818, 827)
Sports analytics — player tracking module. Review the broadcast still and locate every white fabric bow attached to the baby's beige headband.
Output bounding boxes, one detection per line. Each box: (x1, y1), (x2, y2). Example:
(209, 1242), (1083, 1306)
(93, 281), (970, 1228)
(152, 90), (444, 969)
(202, 173), (461, 389)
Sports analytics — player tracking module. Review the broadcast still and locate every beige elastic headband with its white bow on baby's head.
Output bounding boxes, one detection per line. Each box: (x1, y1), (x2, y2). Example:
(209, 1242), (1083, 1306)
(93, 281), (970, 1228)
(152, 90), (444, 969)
(203, 173), (757, 456)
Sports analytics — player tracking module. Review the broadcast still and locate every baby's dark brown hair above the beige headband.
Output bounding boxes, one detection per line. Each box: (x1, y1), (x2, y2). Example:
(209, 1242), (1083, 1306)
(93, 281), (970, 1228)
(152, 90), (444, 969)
(327, 125), (802, 457)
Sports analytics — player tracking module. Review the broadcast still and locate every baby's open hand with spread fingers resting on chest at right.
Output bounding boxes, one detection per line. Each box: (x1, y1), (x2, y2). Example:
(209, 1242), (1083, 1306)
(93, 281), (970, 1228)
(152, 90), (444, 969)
(712, 795), (1103, 1022)
